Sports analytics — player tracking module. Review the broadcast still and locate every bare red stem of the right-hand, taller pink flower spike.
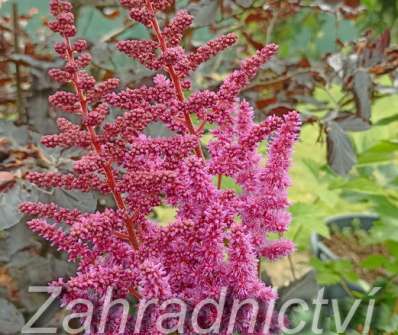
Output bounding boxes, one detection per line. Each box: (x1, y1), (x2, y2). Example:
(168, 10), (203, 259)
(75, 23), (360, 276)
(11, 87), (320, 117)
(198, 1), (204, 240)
(146, 0), (204, 159)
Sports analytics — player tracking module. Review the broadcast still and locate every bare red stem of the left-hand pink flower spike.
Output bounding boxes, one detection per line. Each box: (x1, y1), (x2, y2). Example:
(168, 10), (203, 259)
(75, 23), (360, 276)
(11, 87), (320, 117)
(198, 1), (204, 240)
(65, 37), (139, 250)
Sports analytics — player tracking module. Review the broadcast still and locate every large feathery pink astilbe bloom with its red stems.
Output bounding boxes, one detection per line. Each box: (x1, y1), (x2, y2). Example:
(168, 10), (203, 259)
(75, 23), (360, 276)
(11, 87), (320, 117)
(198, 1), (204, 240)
(20, 0), (300, 334)
